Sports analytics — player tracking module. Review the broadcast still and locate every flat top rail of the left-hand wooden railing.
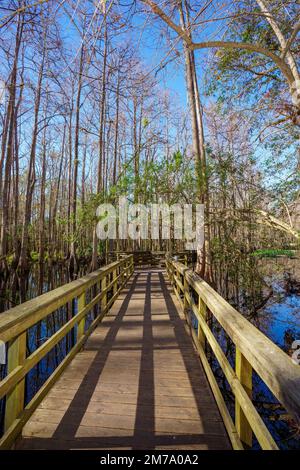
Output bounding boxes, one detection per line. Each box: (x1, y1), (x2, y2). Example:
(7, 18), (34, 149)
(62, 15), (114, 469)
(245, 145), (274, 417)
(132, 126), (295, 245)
(0, 255), (132, 342)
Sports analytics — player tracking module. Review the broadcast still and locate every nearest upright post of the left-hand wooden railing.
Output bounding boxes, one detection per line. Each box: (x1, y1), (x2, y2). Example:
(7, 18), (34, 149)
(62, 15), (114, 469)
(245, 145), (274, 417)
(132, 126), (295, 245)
(4, 331), (27, 431)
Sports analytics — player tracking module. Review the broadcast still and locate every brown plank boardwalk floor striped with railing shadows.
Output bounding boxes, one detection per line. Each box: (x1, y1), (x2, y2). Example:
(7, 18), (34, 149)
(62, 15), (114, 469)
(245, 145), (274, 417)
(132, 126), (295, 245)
(17, 269), (230, 450)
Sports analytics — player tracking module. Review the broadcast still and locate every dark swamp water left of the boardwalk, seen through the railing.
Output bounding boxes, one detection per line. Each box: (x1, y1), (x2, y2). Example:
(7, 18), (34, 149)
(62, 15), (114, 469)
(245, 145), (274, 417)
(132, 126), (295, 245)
(0, 264), (93, 435)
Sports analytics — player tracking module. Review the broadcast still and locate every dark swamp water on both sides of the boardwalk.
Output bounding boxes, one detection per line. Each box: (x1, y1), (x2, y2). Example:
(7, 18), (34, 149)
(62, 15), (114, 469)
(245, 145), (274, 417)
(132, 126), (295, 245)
(0, 258), (300, 449)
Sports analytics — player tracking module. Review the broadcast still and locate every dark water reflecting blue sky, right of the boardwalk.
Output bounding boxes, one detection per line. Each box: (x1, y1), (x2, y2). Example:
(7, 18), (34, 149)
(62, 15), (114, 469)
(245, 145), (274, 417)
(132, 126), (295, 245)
(204, 258), (300, 449)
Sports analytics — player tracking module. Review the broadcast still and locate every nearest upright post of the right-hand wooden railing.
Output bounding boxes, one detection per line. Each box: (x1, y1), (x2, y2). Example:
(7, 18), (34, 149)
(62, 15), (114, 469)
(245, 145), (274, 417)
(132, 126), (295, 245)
(235, 348), (252, 447)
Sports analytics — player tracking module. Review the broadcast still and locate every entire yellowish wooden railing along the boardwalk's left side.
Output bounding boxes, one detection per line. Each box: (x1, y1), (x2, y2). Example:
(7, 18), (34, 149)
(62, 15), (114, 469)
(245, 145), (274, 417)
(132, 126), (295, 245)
(0, 255), (134, 449)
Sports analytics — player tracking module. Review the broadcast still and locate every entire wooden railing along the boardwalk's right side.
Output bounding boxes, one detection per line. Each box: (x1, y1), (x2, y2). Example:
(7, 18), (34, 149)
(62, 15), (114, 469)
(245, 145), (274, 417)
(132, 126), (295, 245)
(166, 257), (300, 450)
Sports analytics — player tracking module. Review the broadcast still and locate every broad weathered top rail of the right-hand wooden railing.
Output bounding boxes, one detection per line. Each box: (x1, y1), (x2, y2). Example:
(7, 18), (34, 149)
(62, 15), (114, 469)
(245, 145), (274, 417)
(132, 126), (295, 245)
(168, 258), (300, 422)
